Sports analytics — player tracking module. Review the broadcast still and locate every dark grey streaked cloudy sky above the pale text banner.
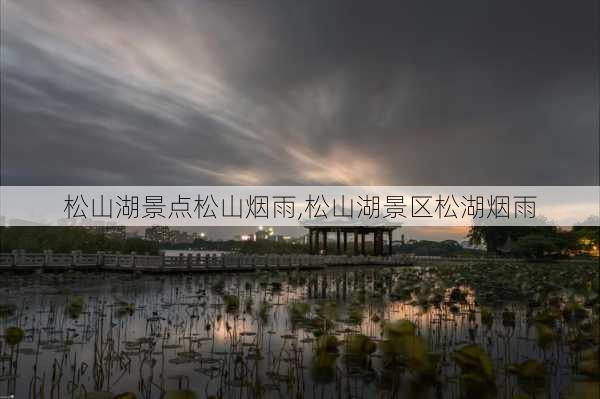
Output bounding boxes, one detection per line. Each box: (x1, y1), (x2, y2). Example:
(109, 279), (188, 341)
(0, 0), (599, 185)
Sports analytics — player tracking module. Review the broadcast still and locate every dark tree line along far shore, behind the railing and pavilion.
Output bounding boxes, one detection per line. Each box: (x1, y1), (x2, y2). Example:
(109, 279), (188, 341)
(0, 226), (600, 257)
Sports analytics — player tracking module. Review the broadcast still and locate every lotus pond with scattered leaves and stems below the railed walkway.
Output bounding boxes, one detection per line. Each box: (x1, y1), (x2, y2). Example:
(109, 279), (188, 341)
(0, 263), (600, 399)
